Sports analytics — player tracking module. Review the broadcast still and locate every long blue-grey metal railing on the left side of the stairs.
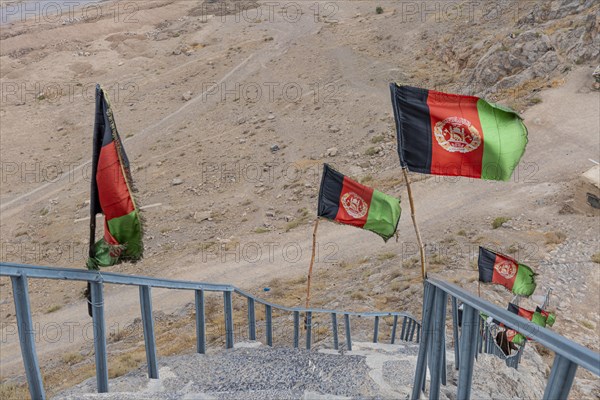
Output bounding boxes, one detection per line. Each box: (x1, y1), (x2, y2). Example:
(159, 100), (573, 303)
(0, 263), (421, 399)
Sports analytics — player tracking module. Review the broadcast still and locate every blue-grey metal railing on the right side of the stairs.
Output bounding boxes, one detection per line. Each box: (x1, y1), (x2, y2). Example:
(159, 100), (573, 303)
(411, 279), (600, 400)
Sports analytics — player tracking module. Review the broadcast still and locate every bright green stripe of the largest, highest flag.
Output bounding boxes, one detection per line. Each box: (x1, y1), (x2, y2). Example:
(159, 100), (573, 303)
(477, 99), (527, 181)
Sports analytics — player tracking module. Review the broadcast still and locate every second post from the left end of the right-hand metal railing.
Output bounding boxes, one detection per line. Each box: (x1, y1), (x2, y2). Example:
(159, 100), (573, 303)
(429, 288), (447, 399)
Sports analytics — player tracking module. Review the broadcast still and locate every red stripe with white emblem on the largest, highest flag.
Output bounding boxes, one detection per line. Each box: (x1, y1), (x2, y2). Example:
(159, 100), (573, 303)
(427, 90), (483, 178)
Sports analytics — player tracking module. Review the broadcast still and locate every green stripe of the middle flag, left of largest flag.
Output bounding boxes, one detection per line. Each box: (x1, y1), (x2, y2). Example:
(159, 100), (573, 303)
(363, 190), (402, 242)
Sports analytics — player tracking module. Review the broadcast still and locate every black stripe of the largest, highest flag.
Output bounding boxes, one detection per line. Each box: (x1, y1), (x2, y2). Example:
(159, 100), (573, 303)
(390, 83), (432, 174)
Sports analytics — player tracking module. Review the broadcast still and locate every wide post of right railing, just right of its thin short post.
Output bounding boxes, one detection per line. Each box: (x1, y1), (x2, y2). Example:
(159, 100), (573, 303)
(457, 304), (481, 400)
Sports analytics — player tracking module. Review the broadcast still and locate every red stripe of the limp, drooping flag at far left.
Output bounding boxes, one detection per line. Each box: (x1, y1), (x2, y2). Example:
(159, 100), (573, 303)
(96, 141), (135, 220)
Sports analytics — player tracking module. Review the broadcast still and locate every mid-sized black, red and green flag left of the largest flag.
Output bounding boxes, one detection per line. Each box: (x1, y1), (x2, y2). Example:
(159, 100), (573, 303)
(318, 164), (402, 242)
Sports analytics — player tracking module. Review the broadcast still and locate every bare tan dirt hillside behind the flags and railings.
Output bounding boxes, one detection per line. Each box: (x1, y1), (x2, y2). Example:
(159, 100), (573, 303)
(0, 1), (600, 398)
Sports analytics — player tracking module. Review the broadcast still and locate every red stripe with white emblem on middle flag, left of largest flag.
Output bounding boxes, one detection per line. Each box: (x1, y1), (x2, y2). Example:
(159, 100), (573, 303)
(335, 176), (373, 228)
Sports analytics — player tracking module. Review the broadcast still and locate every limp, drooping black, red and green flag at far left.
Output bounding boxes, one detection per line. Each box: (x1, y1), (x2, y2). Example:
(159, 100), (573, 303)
(87, 85), (144, 269)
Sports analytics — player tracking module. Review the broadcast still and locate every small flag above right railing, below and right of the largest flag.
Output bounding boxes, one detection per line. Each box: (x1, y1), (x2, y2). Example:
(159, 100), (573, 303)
(477, 247), (536, 297)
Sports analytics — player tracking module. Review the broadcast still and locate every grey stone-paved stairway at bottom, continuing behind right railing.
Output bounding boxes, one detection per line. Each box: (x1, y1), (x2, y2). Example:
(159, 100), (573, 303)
(56, 342), (545, 400)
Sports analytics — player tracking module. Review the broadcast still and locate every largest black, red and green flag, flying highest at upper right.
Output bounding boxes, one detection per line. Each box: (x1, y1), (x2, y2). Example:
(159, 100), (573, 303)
(390, 83), (527, 181)
